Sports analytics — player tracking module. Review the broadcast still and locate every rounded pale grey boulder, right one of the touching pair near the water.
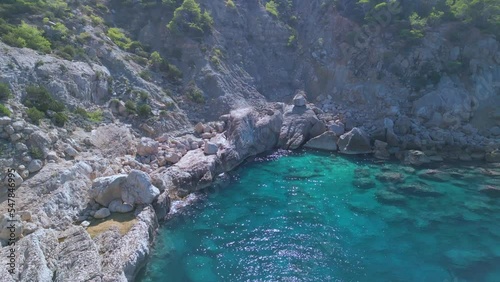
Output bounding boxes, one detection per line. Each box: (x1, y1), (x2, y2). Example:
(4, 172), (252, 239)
(122, 170), (160, 205)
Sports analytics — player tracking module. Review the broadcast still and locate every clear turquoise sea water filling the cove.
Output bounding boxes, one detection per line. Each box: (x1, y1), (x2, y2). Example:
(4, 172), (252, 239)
(138, 152), (500, 282)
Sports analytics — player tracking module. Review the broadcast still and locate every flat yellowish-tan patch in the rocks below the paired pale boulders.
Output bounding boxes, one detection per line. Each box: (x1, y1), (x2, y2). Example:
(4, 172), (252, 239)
(87, 212), (137, 238)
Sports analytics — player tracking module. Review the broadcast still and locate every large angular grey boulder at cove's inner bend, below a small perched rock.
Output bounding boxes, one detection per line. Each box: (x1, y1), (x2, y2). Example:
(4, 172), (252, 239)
(278, 106), (326, 150)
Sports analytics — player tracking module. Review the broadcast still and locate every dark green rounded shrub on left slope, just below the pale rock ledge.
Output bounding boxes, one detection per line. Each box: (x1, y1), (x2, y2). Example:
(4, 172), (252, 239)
(22, 85), (65, 113)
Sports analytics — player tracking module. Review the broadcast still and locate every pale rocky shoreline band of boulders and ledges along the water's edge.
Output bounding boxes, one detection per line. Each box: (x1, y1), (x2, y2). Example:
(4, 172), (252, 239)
(0, 92), (500, 281)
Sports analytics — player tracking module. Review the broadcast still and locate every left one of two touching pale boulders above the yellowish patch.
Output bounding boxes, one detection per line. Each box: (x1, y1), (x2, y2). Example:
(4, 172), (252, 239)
(90, 174), (127, 207)
